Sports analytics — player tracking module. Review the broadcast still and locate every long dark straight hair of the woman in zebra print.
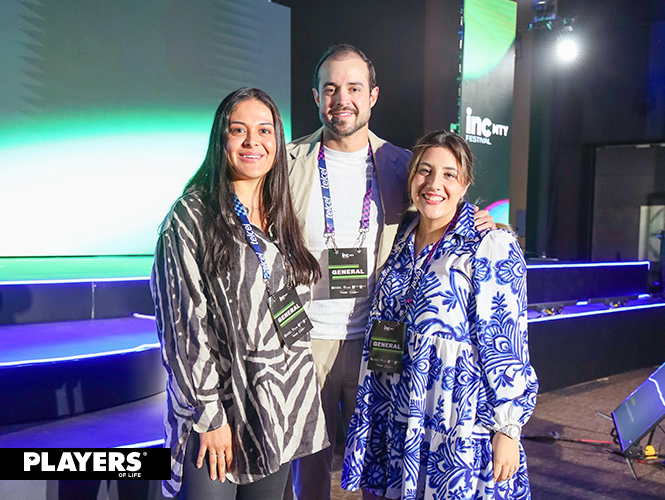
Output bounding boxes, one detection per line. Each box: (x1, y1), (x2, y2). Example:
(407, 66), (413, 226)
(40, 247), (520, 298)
(184, 88), (321, 285)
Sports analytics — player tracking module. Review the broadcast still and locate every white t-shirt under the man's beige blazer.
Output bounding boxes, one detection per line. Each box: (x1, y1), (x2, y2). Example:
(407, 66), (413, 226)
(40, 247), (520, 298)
(305, 146), (383, 340)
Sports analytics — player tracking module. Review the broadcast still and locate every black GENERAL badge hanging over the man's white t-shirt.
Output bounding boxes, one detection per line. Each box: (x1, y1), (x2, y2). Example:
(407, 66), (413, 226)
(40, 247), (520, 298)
(328, 248), (367, 299)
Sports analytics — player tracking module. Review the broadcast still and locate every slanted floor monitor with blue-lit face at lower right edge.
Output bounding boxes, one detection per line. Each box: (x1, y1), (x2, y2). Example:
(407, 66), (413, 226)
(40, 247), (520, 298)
(612, 363), (665, 459)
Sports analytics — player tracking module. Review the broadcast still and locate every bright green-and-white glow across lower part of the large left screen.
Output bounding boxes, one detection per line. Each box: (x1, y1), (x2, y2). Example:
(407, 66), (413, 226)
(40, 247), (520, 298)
(0, 109), (290, 256)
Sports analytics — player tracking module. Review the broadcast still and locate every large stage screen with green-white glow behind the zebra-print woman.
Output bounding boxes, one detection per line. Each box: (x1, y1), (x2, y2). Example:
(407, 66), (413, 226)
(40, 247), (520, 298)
(0, 0), (291, 256)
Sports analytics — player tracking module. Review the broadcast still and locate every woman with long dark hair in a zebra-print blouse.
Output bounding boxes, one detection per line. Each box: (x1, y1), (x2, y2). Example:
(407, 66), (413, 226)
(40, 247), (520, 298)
(151, 89), (328, 500)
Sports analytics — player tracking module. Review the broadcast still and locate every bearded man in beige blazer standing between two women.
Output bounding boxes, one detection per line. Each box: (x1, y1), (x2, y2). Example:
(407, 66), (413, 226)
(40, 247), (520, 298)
(287, 44), (493, 500)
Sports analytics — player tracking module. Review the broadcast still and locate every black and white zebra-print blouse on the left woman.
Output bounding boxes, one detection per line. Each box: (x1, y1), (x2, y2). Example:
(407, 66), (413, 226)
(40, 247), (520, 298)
(151, 193), (328, 497)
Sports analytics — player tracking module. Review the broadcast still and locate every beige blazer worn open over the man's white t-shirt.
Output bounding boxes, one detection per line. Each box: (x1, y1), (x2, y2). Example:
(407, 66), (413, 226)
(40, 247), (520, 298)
(286, 128), (411, 276)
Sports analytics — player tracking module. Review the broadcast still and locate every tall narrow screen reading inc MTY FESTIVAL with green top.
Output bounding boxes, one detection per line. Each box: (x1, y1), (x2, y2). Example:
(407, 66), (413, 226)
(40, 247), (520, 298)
(459, 0), (517, 224)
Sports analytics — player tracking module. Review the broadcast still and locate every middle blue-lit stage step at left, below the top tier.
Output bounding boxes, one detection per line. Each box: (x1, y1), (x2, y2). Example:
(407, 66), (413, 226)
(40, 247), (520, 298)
(0, 317), (166, 425)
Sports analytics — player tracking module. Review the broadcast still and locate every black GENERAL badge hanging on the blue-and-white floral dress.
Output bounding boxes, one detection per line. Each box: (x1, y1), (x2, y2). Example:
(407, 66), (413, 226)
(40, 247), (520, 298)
(367, 320), (406, 373)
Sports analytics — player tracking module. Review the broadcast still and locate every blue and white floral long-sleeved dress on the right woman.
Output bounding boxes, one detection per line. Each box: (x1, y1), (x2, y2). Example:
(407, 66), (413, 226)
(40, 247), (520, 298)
(342, 203), (538, 500)
